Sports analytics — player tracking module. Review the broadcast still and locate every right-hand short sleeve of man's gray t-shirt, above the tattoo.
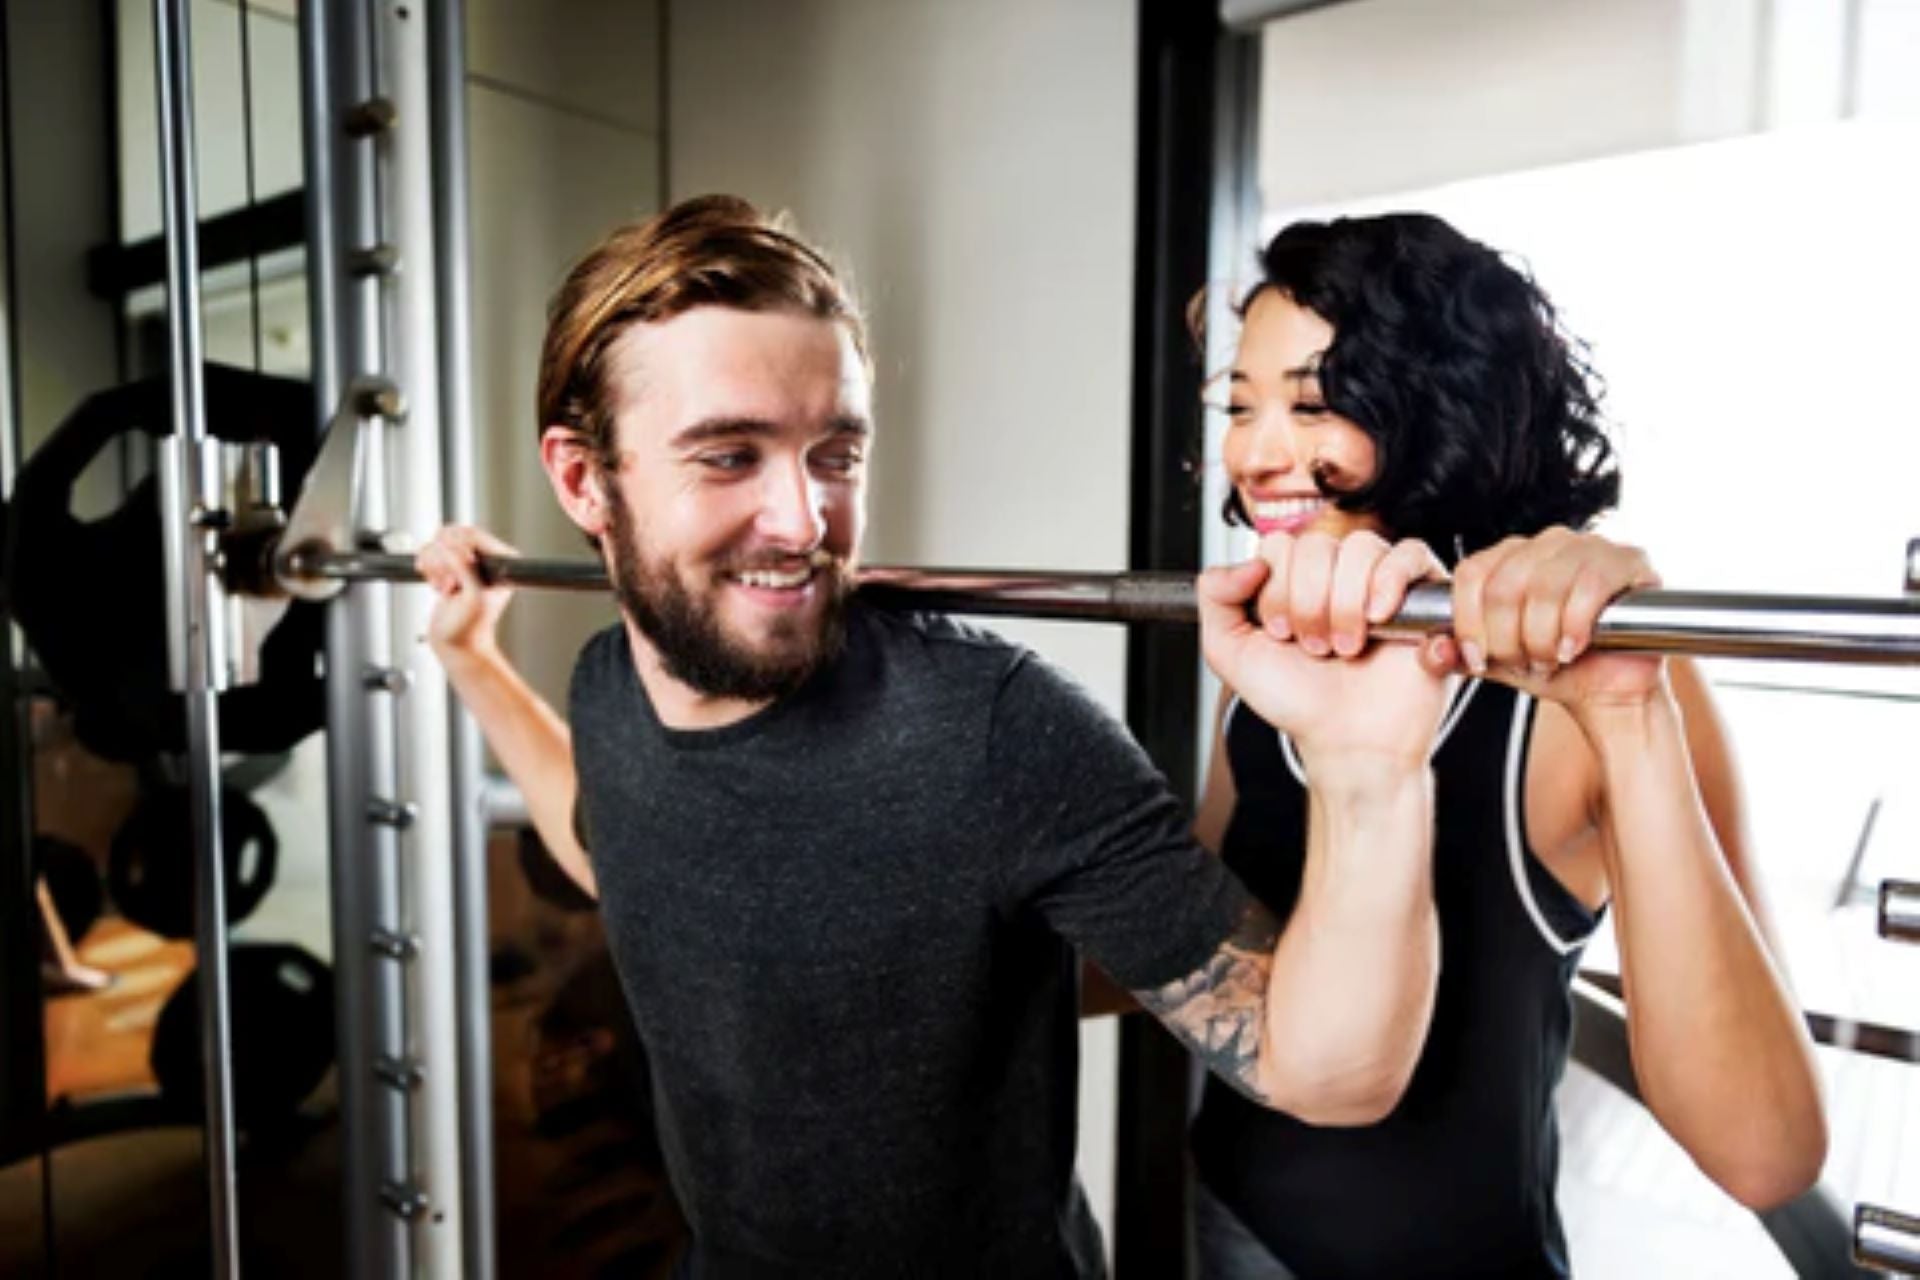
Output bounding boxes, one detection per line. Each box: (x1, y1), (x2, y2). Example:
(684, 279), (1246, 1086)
(987, 654), (1250, 990)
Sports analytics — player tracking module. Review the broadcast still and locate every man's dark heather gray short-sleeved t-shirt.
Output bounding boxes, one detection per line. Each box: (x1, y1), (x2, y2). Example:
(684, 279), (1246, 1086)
(572, 604), (1248, 1276)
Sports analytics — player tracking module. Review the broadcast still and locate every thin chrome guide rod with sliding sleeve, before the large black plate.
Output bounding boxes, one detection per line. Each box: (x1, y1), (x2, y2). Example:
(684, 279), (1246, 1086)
(154, 0), (240, 1276)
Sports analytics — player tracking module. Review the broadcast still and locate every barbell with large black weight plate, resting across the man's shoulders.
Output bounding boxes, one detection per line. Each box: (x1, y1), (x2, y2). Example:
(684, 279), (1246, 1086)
(11, 367), (1920, 760)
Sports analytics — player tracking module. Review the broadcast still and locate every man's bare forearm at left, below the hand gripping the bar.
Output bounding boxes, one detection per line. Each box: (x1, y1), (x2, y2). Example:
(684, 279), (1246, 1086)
(438, 649), (597, 894)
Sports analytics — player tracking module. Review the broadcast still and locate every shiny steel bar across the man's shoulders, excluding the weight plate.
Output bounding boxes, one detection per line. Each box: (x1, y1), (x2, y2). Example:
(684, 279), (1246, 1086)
(282, 547), (1920, 666)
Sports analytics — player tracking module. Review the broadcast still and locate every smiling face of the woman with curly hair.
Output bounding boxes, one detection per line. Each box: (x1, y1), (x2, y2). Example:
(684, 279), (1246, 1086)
(1225, 288), (1380, 537)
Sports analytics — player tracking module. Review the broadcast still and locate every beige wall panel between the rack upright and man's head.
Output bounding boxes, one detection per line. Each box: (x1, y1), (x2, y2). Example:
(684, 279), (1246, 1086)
(467, 0), (660, 706)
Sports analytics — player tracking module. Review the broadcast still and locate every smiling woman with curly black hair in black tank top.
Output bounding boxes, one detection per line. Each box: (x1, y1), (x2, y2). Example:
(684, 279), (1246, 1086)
(1192, 215), (1826, 1280)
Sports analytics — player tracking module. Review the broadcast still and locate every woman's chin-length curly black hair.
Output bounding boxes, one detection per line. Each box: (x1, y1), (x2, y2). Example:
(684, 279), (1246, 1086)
(1227, 213), (1620, 560)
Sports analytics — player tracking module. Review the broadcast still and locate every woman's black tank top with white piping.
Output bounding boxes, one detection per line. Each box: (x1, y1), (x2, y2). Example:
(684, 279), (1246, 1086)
(1192, 681), (1597, 1280)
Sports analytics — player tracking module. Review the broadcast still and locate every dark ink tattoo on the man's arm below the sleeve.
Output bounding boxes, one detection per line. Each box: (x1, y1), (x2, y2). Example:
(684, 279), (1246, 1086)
(1133, 904), (1281, 1103)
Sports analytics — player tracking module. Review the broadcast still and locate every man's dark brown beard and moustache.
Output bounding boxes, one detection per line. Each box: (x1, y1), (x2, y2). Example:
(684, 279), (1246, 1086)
(607, 486), (852, 702)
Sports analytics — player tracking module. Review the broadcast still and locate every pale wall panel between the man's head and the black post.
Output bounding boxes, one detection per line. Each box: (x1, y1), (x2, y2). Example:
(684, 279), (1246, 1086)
(668, 0), (1137, 1258)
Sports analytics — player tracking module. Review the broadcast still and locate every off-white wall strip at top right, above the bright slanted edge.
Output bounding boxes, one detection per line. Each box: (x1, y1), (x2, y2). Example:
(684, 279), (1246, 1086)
(1260, 0), (1920, 209)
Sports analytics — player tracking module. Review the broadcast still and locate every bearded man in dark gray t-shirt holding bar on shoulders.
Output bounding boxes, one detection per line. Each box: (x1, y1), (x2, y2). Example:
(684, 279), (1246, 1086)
(420, 198), (1440, 1276)
